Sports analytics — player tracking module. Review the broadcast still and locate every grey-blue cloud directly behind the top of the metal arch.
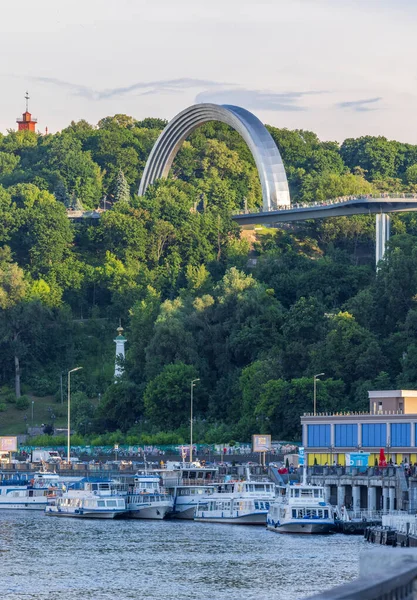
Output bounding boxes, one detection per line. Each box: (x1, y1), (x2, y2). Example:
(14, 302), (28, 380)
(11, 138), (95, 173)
(195, 87), (327, 111)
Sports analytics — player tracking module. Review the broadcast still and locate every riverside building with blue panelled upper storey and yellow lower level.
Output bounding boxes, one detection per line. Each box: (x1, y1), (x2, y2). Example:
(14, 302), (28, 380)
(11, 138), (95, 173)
(301, 390), (417, 466)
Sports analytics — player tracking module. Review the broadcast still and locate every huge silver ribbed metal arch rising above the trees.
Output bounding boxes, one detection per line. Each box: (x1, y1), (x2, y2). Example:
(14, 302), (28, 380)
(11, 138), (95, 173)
(139, 104), (290, 211)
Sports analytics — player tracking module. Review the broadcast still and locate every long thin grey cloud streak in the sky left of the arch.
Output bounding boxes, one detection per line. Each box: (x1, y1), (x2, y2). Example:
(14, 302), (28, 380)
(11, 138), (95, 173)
(32, 77), (233, 101)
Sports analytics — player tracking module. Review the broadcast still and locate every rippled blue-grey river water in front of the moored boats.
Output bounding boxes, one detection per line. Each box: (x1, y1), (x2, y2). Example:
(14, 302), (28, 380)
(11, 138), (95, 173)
(0, 511), (365, 600)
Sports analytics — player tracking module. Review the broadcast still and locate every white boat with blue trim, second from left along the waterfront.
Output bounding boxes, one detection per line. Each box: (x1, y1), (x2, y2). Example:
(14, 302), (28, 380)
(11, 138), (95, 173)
(45, 479), (126, 519)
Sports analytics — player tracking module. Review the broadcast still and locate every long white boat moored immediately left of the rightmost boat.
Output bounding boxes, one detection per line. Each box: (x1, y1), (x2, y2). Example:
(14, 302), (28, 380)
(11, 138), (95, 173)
(194, 480), (275, 525)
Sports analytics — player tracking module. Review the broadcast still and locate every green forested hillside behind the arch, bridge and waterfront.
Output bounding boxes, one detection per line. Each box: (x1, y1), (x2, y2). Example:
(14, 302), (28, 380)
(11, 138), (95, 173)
(0, 115), (417, 442)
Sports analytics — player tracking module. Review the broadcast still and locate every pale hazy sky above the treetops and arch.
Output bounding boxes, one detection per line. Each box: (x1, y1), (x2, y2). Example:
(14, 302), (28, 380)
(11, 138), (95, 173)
(0, 0), (417, 144)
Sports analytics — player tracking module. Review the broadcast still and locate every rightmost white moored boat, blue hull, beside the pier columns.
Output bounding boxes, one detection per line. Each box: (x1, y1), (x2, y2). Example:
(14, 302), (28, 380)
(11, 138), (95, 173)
(267, 483), (335, 533)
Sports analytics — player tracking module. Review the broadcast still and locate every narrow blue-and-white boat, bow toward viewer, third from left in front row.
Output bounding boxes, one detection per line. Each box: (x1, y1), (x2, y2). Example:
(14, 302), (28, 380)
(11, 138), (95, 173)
(126, 473), (174, 519)
